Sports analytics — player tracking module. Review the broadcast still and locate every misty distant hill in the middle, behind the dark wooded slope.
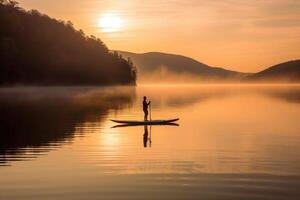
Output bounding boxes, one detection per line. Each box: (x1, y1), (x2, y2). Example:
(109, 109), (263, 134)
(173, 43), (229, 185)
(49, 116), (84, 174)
(118, 51), (248, 82)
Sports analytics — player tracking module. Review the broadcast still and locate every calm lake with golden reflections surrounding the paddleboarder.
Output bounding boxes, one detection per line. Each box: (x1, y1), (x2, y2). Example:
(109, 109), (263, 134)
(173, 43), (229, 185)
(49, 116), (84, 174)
(0, 85), (300, 200)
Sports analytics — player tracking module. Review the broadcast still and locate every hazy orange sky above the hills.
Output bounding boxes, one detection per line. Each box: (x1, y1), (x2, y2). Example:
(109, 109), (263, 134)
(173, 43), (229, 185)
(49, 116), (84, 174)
(19, 0), (300, 72)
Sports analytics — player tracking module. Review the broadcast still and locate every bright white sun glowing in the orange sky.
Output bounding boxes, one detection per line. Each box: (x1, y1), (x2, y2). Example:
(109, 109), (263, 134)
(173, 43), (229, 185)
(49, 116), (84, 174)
(98, 13), (123, 33)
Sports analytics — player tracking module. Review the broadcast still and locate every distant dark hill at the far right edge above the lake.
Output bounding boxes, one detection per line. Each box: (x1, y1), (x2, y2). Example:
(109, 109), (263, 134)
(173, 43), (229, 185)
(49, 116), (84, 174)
(245, 60), (300, 83)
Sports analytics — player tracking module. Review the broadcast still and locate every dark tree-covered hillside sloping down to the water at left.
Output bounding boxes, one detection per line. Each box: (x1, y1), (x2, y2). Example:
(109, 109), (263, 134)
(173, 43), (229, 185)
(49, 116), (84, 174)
(0, 0), (136, 86)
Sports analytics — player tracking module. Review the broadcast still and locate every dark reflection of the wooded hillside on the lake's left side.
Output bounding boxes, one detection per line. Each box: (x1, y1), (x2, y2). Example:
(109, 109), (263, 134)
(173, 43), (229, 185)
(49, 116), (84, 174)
(0, 88), (135, 164)
